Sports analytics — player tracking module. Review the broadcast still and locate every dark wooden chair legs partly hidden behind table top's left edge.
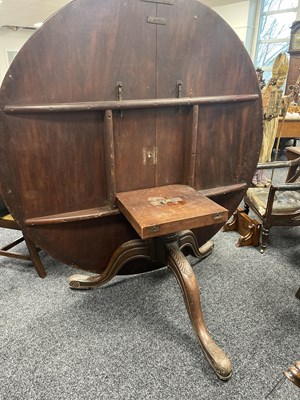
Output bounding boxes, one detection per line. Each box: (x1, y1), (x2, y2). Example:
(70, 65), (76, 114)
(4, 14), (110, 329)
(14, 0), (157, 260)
(0, 198), (47, 278)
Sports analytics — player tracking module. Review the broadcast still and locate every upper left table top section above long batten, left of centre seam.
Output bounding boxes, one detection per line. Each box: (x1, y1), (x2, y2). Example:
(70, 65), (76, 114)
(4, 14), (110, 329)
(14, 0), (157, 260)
(2, 0), (156, 104)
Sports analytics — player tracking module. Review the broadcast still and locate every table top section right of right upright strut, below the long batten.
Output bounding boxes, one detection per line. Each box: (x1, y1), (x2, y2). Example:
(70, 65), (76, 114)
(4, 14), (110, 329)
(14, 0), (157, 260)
(195, 103), (262, 190)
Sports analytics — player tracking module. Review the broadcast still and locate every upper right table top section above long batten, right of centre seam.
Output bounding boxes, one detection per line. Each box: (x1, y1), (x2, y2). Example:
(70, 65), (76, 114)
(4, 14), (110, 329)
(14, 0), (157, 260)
(157, 0), (259, 97)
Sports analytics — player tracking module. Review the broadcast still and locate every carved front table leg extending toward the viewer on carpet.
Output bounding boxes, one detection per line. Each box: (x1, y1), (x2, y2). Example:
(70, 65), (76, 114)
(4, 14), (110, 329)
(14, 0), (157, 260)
(165, 242), (232, 380)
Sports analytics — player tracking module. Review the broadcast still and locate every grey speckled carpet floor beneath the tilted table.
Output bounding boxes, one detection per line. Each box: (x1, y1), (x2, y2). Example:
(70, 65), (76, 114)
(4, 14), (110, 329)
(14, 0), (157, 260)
(0, 166), (300, 400)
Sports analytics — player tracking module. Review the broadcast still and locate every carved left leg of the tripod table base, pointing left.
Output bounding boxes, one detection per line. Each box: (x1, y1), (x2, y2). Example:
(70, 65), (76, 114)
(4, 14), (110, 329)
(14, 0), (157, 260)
(68, 239), (151, 289)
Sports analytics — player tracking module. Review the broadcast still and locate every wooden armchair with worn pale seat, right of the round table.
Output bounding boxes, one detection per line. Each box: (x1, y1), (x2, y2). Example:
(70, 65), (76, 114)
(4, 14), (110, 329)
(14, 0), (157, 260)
(244, 157), (300, 253)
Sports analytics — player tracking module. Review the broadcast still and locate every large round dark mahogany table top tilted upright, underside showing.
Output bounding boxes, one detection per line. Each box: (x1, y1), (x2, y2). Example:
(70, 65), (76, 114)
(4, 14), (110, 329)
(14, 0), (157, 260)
(0, 0), (262, 273)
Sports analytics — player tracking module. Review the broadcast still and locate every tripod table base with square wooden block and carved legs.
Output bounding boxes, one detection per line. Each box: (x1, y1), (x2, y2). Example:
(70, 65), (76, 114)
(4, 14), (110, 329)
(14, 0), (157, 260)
(69, 185), (232, 380)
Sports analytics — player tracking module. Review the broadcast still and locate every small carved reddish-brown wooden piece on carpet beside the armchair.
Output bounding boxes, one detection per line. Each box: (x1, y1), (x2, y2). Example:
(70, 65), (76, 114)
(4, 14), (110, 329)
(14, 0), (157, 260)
(223, 208), (261, 247)
